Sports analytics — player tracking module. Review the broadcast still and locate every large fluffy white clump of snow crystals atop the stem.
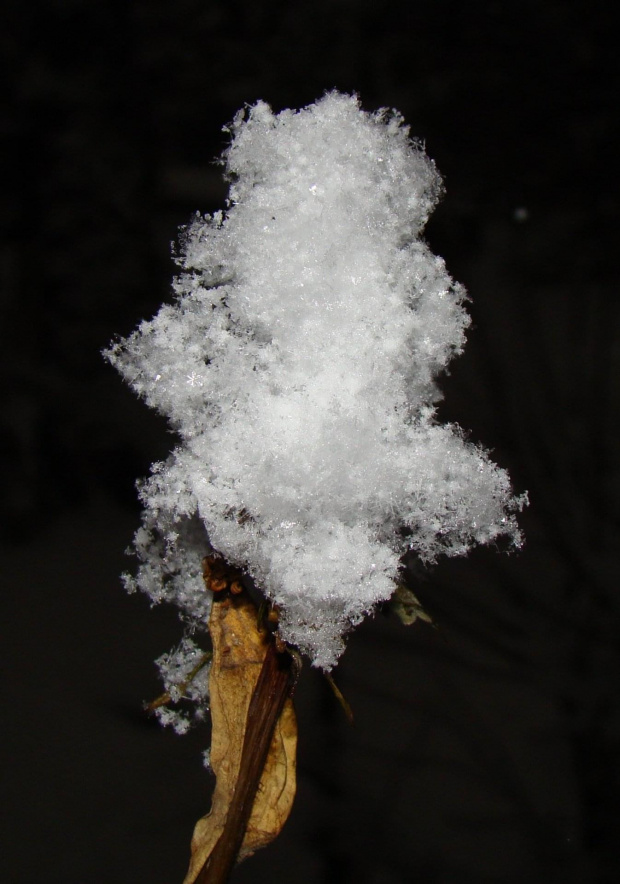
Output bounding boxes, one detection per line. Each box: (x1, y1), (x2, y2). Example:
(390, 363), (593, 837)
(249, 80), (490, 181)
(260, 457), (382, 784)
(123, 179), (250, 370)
(108, 92), (523, 669)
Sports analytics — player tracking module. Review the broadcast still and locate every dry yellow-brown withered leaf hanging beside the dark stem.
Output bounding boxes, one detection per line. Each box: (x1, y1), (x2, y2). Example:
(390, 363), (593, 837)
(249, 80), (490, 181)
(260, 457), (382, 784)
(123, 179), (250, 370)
(183, 592), (297, 884)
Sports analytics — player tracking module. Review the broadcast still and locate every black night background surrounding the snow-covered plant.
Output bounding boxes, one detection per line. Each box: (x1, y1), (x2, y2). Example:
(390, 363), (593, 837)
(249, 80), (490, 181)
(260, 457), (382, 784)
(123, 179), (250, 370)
(0, 0), (620, 884)
